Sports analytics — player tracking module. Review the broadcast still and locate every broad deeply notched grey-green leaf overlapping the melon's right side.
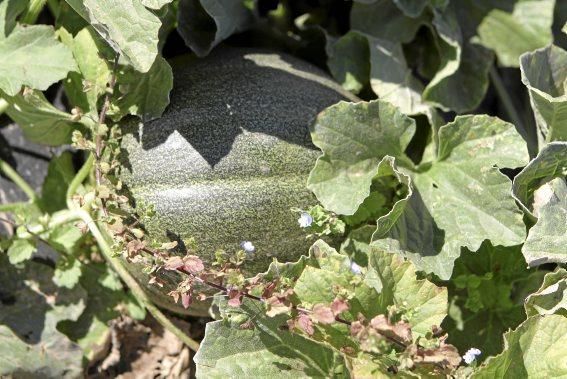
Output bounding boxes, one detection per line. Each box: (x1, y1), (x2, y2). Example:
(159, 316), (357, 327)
(308, 101), (527, 279)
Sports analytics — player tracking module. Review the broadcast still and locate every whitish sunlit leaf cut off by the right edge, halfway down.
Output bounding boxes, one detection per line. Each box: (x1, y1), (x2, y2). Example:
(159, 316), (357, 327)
(522, 178), (567, 266)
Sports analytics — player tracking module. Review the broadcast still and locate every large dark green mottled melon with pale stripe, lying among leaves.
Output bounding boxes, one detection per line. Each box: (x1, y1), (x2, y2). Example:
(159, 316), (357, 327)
(121, 48), (353, 314)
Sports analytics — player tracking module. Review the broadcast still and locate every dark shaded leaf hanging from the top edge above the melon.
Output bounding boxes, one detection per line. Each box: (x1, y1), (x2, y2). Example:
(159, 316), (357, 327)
(177, 0), (253, 57)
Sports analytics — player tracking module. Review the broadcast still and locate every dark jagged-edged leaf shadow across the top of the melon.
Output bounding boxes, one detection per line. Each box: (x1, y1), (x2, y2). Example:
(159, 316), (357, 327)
(125, 47), (348, 168)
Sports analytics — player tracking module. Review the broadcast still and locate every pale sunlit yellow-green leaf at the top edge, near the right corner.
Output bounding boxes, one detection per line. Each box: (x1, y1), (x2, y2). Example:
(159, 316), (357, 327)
(478, 0), (555, 67)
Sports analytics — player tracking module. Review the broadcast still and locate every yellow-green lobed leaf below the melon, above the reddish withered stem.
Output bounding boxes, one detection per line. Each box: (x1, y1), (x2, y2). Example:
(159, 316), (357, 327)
(293, 241), (447, 342)
